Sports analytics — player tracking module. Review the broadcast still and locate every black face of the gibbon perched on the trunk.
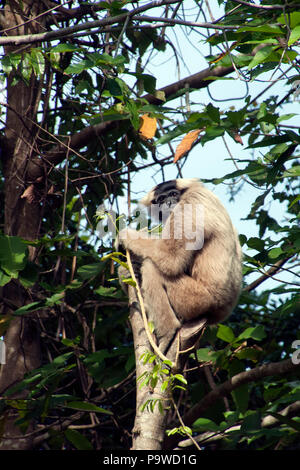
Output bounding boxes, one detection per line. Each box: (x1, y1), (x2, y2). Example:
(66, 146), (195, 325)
(151, 180), (182, 222)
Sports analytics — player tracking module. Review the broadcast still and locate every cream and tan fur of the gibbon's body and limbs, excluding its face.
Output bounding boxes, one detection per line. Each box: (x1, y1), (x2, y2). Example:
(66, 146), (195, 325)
(121, 178), (242, 351)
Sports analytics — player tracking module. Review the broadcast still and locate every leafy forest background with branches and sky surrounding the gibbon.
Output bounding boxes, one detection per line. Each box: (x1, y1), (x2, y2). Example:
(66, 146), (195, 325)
(0, 0), (300, 450)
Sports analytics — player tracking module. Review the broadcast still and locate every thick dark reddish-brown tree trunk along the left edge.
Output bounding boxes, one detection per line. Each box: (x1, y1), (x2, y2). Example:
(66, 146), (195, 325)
(0, 0), (44, 450)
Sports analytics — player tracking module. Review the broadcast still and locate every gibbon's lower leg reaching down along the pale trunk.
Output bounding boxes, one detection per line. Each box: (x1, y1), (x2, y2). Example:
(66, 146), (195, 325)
(141, 258), (181, 353)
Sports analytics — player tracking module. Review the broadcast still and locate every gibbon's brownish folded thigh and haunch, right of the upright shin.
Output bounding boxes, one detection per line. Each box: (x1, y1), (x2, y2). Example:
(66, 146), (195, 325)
(164, 275), (220, 322)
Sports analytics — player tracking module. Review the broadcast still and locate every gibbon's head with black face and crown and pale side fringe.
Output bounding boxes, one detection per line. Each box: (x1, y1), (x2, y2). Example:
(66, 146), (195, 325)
(140, 178), (200, 222)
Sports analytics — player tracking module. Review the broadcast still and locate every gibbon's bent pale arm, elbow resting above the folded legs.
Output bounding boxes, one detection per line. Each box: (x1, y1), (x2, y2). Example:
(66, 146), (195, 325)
(119, 229), (195, 277)
